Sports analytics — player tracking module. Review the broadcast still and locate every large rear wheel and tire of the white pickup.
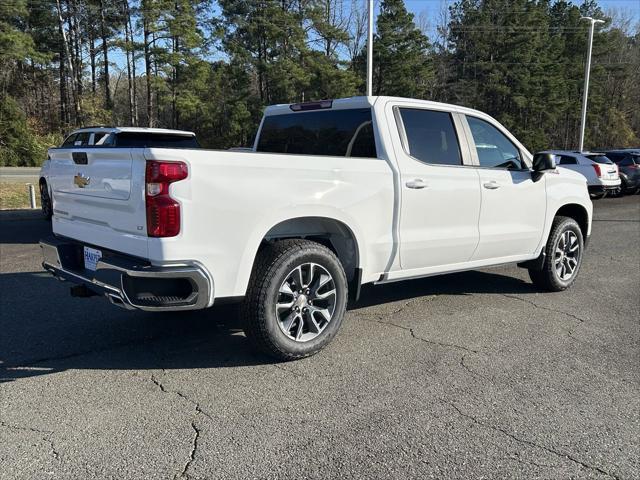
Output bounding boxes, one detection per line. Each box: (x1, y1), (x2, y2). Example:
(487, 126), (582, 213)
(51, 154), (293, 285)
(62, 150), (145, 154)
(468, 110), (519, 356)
(242, 239), (348, 360)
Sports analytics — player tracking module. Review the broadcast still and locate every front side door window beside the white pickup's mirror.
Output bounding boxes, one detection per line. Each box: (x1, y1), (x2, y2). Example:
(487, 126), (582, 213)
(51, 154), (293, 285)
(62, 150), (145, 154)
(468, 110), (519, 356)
(467, 116), (526, 170)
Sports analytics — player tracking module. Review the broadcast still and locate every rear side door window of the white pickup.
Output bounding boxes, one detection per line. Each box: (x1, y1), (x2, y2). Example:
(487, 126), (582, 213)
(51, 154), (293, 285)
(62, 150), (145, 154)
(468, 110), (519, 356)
(400, 108), (462, 165)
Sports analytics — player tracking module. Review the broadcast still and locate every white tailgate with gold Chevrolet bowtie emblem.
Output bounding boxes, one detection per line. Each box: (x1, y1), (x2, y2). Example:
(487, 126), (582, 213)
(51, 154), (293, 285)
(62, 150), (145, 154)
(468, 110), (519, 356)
(48, 147), (148, 257)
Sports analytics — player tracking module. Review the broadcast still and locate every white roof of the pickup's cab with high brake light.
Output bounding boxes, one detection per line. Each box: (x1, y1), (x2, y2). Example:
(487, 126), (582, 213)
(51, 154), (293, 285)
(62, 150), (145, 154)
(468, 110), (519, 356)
(264, 95), (488, 117)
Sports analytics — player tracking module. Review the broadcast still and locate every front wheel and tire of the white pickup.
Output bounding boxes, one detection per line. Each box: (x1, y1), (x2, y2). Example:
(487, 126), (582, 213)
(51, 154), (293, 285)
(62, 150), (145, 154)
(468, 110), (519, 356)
(529, 217), (584, 292)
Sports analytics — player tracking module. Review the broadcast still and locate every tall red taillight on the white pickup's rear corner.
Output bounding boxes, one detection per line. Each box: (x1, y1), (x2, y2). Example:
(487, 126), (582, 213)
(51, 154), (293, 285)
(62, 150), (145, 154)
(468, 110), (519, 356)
(145, 160), (189, 237)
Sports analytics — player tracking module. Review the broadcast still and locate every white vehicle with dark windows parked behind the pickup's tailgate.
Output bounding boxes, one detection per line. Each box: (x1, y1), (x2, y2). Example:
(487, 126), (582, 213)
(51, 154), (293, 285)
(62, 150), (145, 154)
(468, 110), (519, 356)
(38, 126), (200, 219)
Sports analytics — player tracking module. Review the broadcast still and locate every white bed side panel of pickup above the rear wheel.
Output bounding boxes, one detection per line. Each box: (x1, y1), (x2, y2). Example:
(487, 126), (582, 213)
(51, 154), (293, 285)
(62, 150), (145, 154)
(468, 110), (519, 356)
(145, 149), (394, 297)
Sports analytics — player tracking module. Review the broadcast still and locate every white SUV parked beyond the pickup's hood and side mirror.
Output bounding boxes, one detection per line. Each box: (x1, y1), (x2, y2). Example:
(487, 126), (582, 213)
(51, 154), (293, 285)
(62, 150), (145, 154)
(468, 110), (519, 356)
(545, 150), (621, 198)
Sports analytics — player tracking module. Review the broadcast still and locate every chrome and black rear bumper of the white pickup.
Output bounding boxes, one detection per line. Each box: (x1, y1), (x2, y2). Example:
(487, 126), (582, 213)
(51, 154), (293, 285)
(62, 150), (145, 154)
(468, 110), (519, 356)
(40, 237), (213, 311)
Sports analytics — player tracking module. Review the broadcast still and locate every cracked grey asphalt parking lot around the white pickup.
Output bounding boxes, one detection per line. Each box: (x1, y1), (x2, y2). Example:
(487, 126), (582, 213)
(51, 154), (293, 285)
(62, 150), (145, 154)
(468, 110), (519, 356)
(0, 195), (640, 479)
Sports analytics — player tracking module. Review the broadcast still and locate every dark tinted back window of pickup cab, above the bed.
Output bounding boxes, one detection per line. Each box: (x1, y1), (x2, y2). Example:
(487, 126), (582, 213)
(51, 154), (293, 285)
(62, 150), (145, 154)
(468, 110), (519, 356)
(256, 108), (378, 158)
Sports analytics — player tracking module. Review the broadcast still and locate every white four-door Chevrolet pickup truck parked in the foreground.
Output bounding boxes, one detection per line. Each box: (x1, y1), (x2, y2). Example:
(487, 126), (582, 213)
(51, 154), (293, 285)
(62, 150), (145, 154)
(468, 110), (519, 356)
(41, 97), (592, 360)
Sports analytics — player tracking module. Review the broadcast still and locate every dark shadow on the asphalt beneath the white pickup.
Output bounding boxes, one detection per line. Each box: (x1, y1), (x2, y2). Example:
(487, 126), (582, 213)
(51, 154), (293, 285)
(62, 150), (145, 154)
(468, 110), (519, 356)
(0, 271), (534, 382)
